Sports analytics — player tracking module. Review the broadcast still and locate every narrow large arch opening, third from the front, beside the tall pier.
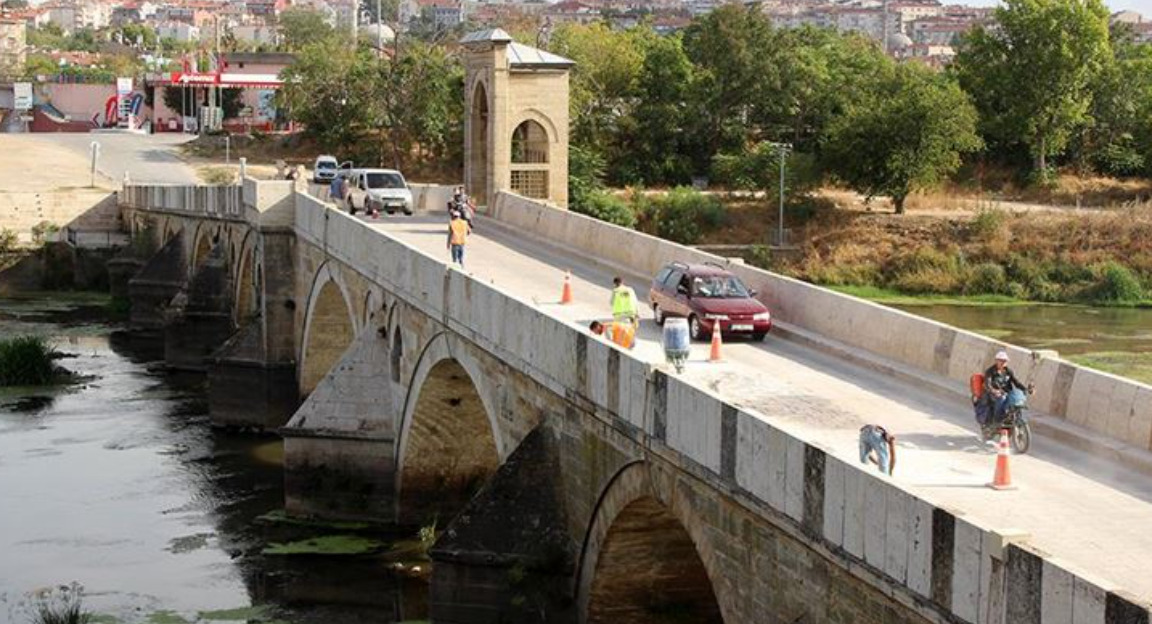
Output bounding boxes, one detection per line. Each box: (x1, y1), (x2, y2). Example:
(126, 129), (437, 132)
(297, 264), (356, 396)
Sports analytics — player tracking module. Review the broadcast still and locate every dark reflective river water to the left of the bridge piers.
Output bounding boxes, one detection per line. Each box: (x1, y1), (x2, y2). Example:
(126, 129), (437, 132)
(0, 300), (427, 624)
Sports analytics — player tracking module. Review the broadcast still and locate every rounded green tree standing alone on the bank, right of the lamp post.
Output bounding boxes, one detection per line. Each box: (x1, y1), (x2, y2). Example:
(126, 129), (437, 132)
(824, 64), (983, 214)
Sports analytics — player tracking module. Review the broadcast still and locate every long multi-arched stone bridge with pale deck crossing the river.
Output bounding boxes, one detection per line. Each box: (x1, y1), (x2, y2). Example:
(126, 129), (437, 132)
(112, 180), (1152, 624)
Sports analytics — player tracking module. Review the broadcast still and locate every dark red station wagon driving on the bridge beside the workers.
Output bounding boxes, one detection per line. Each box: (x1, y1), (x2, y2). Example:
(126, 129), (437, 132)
(649, 262), (772, 340)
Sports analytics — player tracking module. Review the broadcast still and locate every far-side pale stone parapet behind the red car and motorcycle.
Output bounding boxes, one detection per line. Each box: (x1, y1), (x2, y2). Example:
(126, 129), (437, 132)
(491, 192), (1152, 454)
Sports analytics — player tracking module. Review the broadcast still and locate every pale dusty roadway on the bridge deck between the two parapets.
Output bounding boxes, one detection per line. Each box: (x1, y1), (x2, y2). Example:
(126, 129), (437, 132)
(357, 214), (1152, 601)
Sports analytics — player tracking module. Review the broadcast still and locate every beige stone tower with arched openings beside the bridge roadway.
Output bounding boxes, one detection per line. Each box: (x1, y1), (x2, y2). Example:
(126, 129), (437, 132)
(461, 29), (575, 206)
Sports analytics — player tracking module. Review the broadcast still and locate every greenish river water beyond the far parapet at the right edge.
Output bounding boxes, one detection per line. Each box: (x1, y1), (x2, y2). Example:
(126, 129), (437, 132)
(894, 304), (1152, 383)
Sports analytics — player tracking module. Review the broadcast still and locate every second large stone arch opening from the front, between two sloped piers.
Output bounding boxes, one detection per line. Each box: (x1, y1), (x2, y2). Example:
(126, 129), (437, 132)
(396, 334), (505, 524)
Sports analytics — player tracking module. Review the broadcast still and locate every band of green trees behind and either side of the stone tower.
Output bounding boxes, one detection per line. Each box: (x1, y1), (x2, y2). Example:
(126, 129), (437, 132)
(276, 0), (1152, 211)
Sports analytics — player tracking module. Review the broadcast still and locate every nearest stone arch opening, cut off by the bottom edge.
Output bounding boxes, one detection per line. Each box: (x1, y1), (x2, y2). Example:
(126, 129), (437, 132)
(576, 461), (725, 624)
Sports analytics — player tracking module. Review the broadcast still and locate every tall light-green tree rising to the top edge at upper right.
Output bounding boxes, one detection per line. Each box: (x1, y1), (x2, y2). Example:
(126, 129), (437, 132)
(953, 0), (1108, 176)
